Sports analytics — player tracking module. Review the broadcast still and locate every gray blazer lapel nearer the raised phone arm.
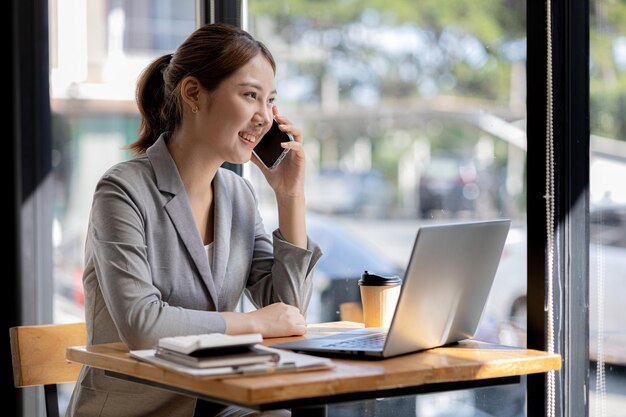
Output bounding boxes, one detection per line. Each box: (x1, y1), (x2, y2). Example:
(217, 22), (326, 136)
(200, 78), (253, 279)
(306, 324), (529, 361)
(211, 170), (232, 294)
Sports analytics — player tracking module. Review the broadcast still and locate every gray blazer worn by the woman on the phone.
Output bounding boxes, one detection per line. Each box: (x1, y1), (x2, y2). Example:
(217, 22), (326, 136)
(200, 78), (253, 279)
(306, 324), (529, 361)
(66, 135), (321, 417)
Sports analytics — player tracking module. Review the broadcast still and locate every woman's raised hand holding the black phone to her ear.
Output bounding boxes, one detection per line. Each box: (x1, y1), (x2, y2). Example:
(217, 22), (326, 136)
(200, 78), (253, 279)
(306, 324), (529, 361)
(252, 106), (305, 198)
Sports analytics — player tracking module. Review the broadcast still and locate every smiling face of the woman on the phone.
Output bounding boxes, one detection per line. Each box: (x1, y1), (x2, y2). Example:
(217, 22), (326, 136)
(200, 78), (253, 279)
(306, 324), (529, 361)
(198, 54), (276, 164)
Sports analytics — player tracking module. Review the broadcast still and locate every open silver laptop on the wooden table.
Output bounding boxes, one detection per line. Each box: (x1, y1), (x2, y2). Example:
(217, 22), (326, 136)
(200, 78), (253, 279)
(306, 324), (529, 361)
(272, 219), (511, 358)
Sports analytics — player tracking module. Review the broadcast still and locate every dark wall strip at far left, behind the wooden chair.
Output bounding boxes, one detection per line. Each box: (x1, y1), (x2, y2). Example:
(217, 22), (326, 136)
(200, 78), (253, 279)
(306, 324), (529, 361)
(8, 0), (53, 416)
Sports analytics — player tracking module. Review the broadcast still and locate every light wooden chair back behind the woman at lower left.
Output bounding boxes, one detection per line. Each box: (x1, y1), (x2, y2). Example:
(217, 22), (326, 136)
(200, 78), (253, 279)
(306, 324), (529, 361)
(9, 323), (87, 417)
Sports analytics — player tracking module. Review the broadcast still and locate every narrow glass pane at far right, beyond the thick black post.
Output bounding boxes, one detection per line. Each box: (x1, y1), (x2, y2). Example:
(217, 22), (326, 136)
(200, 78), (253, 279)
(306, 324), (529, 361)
(589, 0), (626, 417)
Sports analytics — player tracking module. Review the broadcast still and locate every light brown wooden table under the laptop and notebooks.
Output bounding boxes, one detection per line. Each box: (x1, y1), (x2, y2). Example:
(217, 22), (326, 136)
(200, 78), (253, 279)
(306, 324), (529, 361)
(67, 330), (561, 416)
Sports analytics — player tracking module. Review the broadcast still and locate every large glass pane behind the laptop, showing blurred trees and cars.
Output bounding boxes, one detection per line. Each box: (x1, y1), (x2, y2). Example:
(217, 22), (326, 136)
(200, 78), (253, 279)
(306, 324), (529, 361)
(244, 0), (526, 416)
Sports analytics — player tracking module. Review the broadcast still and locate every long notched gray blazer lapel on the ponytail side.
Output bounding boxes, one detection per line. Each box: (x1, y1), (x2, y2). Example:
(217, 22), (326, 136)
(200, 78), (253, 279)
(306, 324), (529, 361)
(146, 135), (218, 308)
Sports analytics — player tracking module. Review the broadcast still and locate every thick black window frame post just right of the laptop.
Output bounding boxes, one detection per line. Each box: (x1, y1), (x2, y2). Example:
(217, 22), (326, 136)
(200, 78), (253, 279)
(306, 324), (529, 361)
(527, 0), (590, 416)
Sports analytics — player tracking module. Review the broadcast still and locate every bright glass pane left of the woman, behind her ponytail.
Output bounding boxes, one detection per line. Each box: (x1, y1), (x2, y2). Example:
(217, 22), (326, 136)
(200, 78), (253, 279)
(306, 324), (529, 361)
(49, 0), (195, 414)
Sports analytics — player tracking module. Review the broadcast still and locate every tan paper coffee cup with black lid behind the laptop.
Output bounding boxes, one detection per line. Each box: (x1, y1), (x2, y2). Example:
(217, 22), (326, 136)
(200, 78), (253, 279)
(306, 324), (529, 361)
(359, 271), (402, 328)
